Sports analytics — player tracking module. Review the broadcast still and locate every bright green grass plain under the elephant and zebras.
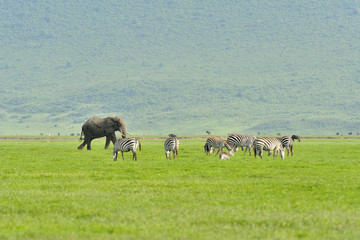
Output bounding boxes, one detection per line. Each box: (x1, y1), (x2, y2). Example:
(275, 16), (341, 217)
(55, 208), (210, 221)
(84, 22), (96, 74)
(0, 139), (360, 239)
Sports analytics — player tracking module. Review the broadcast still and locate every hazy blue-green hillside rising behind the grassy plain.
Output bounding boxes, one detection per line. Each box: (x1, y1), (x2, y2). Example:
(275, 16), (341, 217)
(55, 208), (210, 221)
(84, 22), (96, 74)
(0, 0), (360, 135)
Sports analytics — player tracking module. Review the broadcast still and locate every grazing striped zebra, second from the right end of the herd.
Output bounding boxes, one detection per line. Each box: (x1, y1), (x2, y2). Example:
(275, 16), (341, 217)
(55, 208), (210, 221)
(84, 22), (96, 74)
(254, 138), (285, 159)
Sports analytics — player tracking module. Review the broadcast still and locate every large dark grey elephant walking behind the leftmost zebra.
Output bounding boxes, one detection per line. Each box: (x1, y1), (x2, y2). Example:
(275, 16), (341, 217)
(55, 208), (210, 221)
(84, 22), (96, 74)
(78, 117), (127, 150)
